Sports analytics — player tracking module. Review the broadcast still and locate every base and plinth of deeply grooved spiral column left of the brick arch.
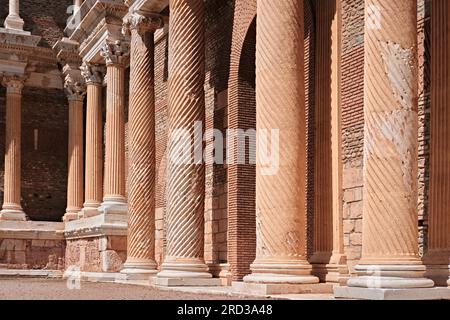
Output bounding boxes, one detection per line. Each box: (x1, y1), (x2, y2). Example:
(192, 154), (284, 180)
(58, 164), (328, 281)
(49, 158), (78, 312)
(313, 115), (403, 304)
(155, 262), (221, 287)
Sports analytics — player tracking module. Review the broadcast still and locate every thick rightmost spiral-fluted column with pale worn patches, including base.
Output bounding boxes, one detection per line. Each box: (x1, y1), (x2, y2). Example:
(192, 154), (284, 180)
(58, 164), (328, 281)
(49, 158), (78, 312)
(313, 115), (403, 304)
(348, 0), (433, 288)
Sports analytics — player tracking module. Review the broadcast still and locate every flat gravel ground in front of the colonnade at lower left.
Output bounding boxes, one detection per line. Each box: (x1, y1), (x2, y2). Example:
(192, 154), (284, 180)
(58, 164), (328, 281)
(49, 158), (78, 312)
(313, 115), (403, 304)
(0, 279), (268, 300)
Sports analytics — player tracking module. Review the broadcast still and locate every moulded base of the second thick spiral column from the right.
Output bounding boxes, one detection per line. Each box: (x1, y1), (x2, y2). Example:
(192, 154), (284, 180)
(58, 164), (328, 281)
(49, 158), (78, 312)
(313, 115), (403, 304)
(244, 261), (319, 284)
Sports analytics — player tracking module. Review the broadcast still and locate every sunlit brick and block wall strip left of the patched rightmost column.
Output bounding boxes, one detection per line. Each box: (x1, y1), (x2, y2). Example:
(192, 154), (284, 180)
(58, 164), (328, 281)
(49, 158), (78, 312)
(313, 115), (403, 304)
(341, 0), (364, 272)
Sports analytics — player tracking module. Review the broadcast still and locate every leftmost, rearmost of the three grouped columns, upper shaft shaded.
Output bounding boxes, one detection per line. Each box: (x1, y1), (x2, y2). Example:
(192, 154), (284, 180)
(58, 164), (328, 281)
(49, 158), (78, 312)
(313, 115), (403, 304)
(64, 76), (86, 221)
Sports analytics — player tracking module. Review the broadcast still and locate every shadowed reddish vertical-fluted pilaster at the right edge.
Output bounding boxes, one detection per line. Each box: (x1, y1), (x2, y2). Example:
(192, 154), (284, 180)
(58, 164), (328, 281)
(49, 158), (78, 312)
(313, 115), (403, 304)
(425, 0), (450, 285)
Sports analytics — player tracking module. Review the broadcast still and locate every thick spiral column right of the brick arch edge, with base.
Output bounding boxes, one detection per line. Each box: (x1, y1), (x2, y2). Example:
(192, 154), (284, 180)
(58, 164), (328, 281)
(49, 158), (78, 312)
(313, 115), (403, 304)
(244, 0), (319, 285)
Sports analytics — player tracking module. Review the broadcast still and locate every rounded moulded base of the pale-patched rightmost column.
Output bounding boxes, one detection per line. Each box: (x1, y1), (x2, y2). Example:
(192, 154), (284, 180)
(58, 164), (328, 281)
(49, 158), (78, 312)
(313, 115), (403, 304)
(347, 265), (434, 289)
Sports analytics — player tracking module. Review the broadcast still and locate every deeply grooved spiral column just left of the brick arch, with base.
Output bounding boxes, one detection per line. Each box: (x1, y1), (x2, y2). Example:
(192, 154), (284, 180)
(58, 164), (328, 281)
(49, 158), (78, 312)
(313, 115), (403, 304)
(158, 0), (211, 278)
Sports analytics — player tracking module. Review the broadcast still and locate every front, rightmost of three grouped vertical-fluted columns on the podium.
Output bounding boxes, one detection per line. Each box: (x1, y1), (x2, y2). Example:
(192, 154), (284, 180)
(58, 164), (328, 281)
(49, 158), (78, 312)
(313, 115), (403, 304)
(99, 41), (129, 214)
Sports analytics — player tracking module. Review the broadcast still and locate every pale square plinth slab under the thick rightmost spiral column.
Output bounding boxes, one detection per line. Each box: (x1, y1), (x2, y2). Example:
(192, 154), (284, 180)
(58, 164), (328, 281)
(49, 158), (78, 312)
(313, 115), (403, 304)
(334, 286), (450, 300)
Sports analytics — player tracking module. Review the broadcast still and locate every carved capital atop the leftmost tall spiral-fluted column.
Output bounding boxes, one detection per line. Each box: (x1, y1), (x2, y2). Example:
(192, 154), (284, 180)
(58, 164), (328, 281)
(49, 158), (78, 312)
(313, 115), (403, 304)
(122, 11), (164, 36)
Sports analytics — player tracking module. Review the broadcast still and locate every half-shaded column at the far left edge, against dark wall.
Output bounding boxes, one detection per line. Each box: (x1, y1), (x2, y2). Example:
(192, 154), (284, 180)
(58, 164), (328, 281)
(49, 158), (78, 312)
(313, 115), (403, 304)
(0, 76), (27, 221)
